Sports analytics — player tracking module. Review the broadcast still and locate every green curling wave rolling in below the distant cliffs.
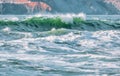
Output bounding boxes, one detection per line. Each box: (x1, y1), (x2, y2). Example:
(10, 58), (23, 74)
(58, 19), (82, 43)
(0, 17), (120, 32)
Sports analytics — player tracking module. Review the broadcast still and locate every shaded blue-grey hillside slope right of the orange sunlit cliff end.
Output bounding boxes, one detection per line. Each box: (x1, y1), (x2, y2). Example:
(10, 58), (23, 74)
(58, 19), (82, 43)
(46, 0), (120, 14)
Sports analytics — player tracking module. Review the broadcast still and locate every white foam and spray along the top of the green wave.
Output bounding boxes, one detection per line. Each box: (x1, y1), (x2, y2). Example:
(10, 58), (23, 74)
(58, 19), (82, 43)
(0, 13), (86, 22)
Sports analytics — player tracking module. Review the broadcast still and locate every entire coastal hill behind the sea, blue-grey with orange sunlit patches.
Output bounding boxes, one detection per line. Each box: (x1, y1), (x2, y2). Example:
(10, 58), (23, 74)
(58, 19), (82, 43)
(0, 0), (120, 15)
